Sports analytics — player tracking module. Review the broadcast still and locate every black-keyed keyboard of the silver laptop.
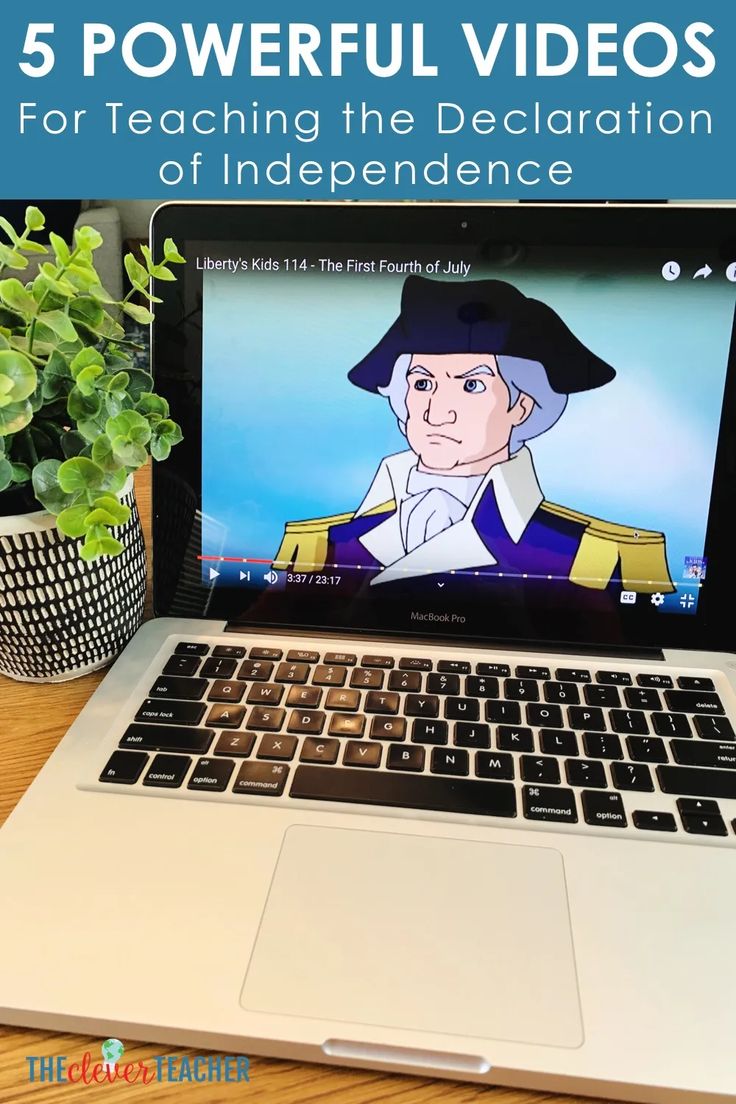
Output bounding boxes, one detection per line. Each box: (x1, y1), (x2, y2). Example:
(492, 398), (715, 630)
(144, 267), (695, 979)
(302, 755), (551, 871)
(99, 640), (736, 840)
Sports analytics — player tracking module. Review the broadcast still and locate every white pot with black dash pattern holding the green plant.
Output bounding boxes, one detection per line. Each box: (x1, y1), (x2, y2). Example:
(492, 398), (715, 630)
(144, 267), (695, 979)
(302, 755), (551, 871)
(0, 480), (146, 682)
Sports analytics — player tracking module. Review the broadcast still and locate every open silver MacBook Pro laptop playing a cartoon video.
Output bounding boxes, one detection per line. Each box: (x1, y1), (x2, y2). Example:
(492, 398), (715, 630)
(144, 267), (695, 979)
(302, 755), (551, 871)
(0, 203), (736, 1104)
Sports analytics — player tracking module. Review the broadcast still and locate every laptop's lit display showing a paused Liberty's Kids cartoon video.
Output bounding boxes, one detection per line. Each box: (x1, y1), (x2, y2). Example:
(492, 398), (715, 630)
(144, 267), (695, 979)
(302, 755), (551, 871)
(150, 212), (736, 641)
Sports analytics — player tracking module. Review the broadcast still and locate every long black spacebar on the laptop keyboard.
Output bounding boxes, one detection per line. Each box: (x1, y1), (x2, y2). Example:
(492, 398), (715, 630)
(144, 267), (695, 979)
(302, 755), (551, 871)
(290, 766), (516, 817)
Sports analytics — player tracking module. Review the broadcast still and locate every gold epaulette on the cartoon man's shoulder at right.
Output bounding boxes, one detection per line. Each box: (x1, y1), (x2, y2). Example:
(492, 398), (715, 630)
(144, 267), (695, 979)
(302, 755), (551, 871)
(541, 501), (676, 594)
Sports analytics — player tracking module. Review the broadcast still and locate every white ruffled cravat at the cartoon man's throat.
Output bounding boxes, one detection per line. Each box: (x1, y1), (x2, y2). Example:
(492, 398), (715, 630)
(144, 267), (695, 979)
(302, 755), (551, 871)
(399, 468), (484, 553)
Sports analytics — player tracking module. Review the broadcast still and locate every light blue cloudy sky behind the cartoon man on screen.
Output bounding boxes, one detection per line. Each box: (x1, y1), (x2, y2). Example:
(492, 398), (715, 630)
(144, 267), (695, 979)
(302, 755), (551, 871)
(203, 246), (736, 609)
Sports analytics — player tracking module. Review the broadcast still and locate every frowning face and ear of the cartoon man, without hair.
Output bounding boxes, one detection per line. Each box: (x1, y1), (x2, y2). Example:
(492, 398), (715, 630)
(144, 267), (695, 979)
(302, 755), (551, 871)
(406, 352), (534, 475)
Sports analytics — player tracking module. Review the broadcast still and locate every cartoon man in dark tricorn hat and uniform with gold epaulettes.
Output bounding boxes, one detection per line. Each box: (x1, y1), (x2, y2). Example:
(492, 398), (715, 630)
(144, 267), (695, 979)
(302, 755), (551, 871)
(274, 276), (674, 593)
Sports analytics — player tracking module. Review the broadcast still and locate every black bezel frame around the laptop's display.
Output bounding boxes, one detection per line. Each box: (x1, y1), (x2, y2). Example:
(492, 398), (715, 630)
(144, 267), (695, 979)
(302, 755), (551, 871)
(151, 202), (736, 651)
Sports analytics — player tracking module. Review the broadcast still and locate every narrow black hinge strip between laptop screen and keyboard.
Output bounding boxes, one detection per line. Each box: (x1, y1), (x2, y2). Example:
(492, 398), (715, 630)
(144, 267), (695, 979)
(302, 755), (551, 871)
(225, 622), (664, 662)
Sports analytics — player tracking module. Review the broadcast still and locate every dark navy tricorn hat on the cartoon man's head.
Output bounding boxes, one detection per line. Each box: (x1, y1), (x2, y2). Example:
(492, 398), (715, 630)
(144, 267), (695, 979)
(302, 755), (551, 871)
(348, 276), (616, 395)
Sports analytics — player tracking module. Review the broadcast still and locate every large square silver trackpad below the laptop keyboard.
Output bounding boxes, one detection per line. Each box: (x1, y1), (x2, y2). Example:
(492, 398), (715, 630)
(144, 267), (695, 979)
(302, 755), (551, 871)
(241, 826), (583, 1047)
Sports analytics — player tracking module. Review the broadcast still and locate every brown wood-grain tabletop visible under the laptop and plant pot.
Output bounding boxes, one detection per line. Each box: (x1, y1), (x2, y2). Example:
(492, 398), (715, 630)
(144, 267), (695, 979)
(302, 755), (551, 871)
(0, 470), (600, 1104)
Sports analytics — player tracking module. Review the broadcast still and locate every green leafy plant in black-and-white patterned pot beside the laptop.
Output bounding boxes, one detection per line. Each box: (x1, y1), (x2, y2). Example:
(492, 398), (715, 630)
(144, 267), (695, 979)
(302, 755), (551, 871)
(0, 208), (183, 681)
